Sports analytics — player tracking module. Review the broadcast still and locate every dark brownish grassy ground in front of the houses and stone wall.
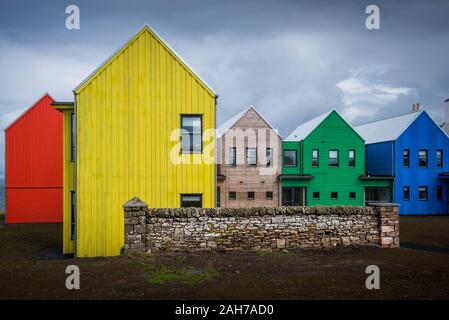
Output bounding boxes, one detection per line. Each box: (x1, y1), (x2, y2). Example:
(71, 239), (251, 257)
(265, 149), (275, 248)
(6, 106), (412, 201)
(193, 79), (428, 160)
(0, 217), (449, 299)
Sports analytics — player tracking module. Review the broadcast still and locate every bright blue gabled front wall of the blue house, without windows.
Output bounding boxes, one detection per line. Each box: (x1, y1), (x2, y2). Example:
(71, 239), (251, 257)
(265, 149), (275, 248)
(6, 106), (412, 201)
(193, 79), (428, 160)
(393, 112), (449, 214)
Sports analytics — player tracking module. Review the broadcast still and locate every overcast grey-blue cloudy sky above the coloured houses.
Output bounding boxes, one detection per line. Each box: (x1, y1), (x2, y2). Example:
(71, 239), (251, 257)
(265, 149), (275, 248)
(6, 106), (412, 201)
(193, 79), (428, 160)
(0, 0), (449, 176)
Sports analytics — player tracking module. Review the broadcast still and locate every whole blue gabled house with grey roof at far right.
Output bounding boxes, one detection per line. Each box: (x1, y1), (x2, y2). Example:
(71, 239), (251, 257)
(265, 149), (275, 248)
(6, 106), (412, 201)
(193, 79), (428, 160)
(355, 111), (449, 214)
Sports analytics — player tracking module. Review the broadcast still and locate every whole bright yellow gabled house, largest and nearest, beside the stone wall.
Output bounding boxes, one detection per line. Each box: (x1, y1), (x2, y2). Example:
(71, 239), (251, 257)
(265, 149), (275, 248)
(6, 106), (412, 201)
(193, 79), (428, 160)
(54, 26), (217, 257)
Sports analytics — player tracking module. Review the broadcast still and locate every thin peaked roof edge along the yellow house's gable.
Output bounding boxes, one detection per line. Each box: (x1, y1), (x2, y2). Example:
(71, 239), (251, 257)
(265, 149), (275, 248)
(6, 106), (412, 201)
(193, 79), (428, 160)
(73, 24), (218, 97)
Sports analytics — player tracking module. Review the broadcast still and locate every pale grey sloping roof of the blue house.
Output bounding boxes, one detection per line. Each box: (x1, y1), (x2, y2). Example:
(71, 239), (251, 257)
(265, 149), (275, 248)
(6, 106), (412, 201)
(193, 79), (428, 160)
(354, 110), (425, 144)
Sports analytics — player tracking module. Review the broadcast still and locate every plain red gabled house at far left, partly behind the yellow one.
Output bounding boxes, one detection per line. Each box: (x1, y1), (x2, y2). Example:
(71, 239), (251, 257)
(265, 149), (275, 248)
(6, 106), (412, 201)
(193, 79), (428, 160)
(5, 94), (63, 223)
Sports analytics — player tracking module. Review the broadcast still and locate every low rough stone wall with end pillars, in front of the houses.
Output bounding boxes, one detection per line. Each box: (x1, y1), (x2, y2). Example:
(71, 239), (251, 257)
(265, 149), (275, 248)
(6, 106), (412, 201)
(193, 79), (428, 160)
(124, 198), (399, 253)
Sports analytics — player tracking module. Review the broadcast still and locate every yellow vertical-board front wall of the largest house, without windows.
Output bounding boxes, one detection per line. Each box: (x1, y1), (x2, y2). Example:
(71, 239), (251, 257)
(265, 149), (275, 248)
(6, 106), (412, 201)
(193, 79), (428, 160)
(76, 32), (215, 257)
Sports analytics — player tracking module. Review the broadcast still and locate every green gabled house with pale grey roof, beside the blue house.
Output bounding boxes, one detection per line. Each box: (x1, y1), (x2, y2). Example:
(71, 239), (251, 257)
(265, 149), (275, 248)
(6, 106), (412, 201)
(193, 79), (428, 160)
(280, 110), (393, 206)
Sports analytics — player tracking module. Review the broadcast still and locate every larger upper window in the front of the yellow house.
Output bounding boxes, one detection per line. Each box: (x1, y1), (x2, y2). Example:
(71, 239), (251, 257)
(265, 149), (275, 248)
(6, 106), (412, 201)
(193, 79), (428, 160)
(181, 115), (203, 153)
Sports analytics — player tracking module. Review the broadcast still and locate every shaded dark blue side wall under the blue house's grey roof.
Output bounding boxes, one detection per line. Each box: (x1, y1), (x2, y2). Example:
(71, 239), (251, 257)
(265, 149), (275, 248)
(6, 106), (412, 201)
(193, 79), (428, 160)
(366, 141), (394, 176)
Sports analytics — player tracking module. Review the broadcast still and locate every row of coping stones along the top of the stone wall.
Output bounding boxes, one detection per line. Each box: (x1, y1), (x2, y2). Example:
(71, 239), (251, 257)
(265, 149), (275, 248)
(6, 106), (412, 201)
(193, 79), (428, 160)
(143, 206), (376, 218)
